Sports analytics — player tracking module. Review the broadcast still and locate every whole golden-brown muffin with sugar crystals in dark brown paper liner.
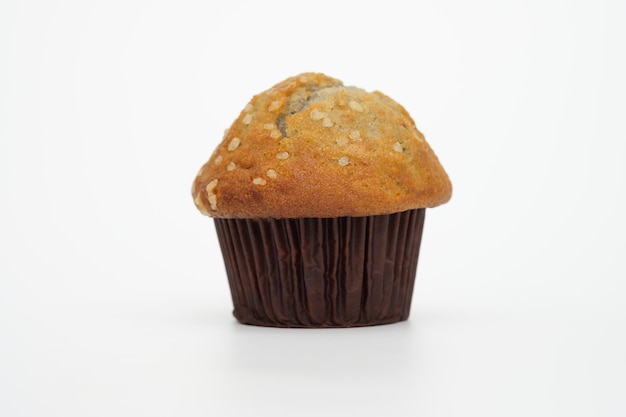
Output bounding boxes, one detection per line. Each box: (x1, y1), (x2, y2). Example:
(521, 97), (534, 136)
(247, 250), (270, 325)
(192, 73), (452, 327)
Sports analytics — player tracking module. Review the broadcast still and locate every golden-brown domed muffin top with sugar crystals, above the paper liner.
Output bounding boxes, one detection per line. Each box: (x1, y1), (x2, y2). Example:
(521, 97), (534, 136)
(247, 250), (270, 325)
(192, 73), (452, 218)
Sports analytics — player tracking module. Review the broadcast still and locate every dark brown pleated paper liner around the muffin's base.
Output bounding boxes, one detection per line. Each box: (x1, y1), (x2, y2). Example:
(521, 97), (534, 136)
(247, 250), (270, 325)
(214, 209), (425, 327)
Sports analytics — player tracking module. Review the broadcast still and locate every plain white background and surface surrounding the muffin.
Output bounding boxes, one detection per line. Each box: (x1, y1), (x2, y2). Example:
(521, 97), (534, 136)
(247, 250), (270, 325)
(0, 0), (626, 417)
